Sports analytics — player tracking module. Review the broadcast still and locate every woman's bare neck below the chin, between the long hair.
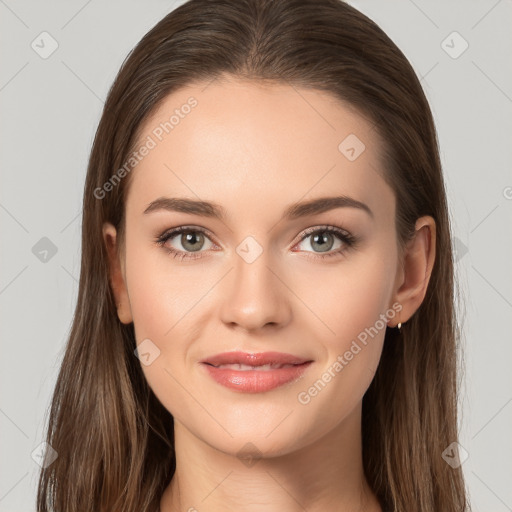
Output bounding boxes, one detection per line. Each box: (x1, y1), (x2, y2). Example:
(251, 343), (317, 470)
(160, 405), (381, 512)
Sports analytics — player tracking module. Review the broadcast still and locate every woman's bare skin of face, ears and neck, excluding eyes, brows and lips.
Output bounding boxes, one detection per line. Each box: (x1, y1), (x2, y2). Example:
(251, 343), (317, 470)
(104, 77), (435, 512)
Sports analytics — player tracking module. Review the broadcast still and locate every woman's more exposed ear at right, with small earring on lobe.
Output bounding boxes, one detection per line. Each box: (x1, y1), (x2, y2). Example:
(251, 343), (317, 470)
(388, 215), (436, 323)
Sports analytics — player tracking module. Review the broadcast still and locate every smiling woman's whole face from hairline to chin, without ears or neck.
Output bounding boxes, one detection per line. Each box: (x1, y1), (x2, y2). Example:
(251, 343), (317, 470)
(107, 79), (404, 455)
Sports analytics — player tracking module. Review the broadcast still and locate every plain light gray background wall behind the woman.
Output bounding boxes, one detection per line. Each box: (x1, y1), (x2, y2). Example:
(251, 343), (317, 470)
(0, 0), (512, 512)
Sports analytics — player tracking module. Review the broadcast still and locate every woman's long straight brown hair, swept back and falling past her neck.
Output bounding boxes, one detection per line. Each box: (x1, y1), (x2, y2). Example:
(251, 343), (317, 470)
(37, 0), (469, 512)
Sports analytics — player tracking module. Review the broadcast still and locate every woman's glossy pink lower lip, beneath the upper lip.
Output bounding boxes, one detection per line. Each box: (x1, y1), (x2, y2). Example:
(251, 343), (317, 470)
(203, 361), (311, 393)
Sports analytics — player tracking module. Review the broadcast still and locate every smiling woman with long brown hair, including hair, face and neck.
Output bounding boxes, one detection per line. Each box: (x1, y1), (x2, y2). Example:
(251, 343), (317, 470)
(37, 0), (468, 512)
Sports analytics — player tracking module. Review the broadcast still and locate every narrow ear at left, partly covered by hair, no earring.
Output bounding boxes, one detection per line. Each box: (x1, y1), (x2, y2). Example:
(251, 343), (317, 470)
(103, 222), (133, 324)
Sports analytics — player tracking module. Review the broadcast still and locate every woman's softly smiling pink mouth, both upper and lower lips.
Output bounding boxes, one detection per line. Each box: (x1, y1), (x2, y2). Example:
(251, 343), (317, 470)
(201, 352), (313, 393)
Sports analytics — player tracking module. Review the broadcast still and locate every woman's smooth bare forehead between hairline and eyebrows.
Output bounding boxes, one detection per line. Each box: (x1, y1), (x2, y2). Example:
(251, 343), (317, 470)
(127, 79), (394, 224)
